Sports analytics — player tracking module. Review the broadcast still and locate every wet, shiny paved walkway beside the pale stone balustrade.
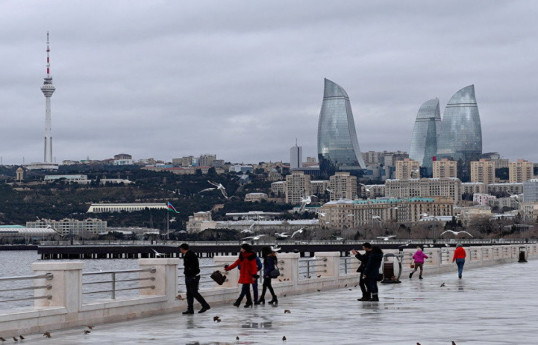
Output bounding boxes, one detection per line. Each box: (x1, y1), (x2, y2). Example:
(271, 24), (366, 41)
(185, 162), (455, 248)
(12, 260), (538, 345)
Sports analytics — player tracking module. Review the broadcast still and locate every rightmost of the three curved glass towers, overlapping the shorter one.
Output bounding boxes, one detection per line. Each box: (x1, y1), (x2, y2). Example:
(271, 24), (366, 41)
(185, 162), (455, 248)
(437, 85), (482, 180)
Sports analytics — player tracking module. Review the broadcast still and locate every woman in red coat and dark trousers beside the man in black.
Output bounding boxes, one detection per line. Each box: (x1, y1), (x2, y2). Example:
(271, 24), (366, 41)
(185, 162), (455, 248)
(224, 243), (259, 308)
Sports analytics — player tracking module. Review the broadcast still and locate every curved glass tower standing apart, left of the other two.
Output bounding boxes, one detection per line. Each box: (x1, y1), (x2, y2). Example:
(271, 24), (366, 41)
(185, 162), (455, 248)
(318, 79), (366, 170)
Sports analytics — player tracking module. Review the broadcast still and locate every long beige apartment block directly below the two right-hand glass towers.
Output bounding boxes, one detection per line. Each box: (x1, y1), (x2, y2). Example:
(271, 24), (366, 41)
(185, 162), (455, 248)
(385, 178), (462, 204)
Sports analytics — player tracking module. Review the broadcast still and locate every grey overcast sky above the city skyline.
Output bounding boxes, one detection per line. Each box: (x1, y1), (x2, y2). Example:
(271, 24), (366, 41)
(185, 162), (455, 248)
(0, 0), (538, 164)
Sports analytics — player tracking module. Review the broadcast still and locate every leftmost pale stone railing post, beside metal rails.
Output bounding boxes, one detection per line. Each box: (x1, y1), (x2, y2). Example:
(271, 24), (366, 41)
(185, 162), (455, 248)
(32, 261), (84, 313)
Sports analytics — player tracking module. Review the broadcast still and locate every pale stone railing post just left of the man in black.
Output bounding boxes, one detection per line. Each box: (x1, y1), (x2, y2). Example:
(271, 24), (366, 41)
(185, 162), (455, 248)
(138, 258), (179, 302)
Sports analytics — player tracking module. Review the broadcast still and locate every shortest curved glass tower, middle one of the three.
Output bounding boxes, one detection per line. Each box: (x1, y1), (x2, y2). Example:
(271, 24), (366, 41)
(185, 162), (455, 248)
(409, 98), (441, 173)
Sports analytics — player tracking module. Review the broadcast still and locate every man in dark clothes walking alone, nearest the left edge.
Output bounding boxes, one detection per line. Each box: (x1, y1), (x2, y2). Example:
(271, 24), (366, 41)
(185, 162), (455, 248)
(179, 243), (211, 315)
